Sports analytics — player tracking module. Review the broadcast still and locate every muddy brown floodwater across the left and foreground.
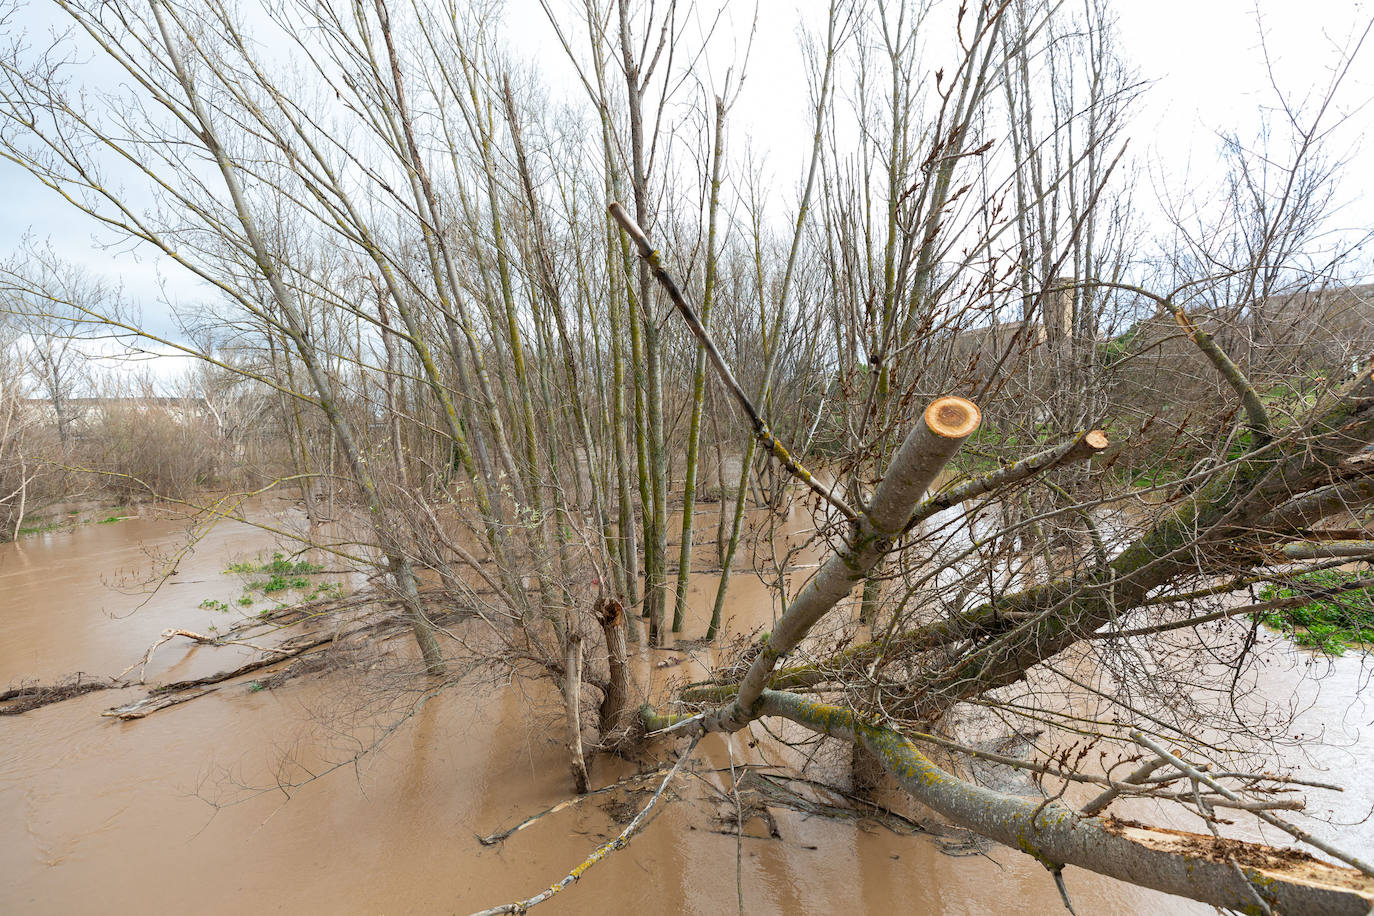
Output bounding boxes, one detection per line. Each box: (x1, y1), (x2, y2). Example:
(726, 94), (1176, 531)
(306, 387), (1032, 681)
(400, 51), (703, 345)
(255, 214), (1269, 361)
(8, 502), (1370, 916)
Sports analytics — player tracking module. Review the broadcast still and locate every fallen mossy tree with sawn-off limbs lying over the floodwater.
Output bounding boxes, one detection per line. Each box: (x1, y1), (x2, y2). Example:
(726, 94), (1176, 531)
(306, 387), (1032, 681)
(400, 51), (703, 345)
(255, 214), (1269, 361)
(611, 205), (1374, 913)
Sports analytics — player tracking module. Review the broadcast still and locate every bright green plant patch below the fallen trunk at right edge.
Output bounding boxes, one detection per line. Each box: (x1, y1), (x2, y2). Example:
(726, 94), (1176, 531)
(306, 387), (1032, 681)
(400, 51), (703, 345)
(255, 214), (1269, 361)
(1259, 570), (1374, 655)
